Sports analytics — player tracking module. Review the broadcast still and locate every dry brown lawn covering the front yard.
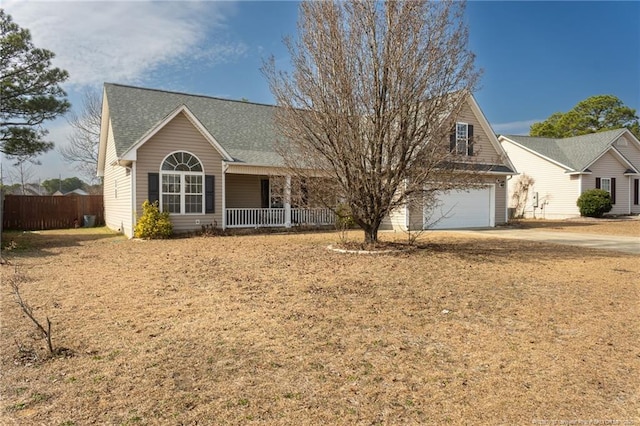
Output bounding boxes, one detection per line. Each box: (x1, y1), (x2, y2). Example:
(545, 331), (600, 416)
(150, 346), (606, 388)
(0, 225), (640, 425)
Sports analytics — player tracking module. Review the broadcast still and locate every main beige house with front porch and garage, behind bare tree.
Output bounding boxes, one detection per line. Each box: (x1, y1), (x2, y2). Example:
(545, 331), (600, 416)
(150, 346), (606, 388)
(98, 83), (514, 237)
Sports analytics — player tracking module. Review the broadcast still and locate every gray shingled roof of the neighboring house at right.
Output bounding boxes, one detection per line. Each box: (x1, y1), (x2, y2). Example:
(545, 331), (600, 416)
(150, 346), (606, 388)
(504, 129), (626, 171)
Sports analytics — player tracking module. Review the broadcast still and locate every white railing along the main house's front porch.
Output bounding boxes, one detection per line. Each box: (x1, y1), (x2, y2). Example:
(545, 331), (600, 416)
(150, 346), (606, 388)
(226, 208), (335, 228)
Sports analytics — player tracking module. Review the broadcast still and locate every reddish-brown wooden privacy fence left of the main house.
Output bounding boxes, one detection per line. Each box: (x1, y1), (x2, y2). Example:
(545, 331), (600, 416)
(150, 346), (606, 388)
(2, 195), (104, 231)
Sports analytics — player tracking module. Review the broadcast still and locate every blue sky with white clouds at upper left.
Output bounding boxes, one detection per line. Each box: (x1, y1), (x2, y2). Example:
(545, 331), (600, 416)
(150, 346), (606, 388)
(3, 0), (640, 181)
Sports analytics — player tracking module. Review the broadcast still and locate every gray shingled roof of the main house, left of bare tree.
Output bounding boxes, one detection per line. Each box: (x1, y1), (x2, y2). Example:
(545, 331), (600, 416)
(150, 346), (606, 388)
(104, 83), (283, 166)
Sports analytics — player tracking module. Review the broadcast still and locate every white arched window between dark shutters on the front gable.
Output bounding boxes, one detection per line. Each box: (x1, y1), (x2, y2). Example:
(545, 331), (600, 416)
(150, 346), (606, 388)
(160, 151), (204, 214)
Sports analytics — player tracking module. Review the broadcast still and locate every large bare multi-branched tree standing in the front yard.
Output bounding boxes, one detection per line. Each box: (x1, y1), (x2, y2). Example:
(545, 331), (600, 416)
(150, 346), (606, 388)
(263, 0), (479, 243)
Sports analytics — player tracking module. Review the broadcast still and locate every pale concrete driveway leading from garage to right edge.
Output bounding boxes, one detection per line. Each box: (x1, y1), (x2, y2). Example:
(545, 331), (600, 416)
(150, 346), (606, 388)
(456, 228), (640, 255)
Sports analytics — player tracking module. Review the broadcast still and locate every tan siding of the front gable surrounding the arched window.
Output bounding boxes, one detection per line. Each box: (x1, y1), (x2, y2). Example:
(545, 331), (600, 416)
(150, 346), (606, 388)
(135, 113), (222, 233)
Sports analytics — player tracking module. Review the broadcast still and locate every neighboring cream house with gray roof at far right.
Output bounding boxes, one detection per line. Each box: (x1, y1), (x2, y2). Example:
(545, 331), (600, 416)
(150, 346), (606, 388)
(499, 129), (640, 219)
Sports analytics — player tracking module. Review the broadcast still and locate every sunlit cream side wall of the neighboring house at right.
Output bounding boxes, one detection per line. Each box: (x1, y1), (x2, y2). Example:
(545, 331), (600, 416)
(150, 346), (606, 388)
(496, 141), (580, 219)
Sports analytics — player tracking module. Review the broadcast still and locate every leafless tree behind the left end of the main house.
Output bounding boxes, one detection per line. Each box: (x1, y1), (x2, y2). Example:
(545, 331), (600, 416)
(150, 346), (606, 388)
(59, 90), (102, 183)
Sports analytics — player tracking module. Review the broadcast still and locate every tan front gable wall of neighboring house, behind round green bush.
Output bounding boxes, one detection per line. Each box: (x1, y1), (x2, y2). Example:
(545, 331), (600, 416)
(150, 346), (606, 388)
(582, 151), (633, 214)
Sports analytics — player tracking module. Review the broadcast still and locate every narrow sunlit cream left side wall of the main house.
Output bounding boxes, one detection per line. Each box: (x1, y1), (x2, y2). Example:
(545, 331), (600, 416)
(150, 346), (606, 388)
(103, 122), (133, 238)
